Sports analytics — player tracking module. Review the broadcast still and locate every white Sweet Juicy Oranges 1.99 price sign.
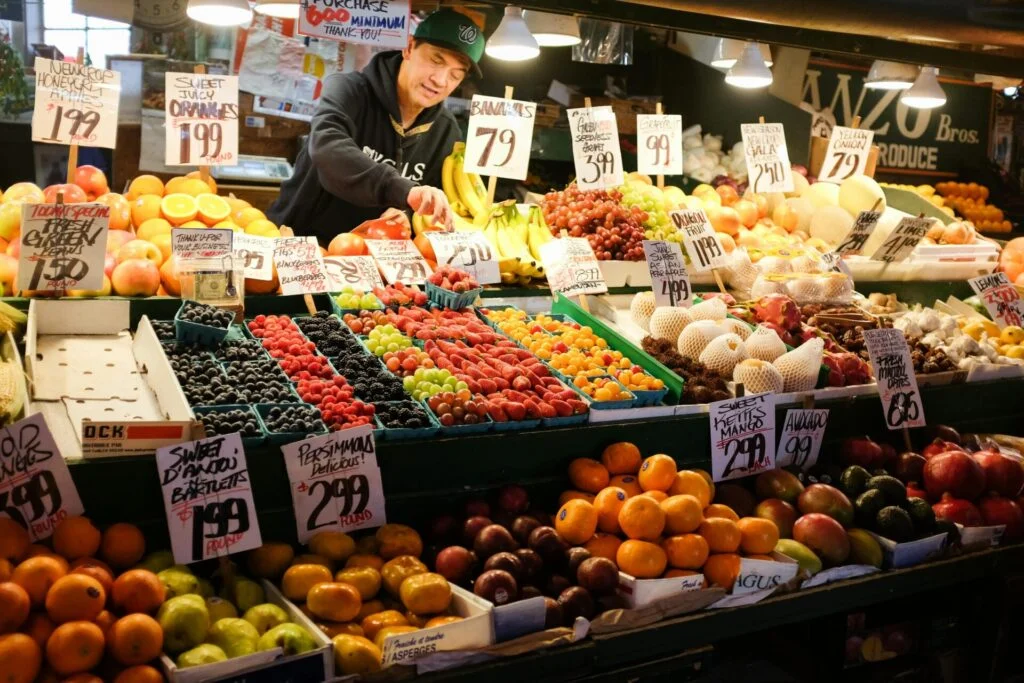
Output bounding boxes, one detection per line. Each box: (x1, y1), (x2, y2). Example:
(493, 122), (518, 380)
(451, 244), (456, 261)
(164, 72), (239, 166)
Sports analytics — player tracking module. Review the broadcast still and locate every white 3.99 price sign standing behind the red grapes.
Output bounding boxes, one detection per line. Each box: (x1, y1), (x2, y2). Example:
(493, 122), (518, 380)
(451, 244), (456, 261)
(567, 106), (624, 189)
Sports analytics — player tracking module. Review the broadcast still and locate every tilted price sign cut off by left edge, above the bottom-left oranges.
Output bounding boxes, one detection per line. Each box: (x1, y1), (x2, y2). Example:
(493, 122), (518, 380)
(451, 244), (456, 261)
(0, 413), (85, 541)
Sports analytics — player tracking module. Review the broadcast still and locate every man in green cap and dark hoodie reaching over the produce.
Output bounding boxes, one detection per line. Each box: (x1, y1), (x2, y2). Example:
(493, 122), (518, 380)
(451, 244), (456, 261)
(268, 9), (483, 245)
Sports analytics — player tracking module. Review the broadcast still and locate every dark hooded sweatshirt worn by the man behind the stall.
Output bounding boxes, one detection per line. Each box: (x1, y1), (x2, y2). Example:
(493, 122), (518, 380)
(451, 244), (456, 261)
(267, 52), (461, 247)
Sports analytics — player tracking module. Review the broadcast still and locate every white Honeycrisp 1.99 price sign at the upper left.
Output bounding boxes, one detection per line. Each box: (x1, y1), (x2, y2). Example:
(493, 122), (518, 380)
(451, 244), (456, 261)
(32, 57), (121, 150)
